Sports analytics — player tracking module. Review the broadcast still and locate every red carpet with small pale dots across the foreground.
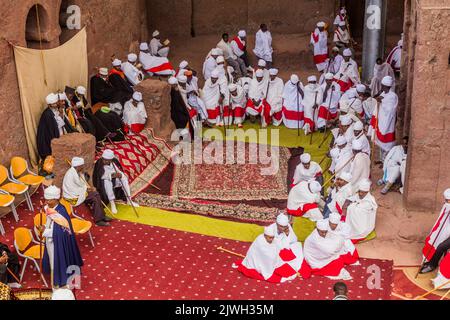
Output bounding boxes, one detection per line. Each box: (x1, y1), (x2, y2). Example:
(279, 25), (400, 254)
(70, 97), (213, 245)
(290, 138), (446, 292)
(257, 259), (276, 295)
(1, 190), (392, 300)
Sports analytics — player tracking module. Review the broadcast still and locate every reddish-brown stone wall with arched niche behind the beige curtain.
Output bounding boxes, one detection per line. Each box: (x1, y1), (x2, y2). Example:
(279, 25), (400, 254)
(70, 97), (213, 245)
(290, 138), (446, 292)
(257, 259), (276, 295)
(0, 0), (147, 164)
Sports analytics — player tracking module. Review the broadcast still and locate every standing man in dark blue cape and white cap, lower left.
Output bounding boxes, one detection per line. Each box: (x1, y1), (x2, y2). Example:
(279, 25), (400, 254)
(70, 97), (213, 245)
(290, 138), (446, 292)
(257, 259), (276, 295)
(42, 186), (83, 288)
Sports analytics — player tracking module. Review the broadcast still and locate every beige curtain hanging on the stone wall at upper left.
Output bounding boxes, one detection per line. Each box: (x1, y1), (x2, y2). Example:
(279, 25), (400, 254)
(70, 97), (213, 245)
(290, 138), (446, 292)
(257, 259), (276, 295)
(14, 28), (88, 165)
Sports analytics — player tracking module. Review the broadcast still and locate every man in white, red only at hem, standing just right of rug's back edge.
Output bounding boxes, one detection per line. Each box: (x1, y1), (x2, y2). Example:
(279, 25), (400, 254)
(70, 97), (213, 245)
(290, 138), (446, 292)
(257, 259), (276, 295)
(303, 76), (323, 135)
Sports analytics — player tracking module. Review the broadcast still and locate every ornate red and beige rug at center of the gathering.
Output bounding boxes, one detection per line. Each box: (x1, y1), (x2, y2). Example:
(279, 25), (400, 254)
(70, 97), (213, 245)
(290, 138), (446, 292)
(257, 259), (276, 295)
(171, 142), (290, 201)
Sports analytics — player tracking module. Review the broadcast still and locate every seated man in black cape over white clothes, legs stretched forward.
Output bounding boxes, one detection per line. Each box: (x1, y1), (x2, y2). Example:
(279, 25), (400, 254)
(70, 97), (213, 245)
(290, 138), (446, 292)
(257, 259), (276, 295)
(93, 149), (139, 214)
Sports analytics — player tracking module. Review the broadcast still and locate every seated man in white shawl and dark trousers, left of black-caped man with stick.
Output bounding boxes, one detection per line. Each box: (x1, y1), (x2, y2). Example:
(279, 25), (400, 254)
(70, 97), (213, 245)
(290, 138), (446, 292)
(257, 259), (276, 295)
(63, 157), (112, 227)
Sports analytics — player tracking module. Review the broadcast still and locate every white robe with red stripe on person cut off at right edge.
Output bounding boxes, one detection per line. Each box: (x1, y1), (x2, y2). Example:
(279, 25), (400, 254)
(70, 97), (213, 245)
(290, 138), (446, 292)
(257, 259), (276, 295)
(422, 203), (450, 261)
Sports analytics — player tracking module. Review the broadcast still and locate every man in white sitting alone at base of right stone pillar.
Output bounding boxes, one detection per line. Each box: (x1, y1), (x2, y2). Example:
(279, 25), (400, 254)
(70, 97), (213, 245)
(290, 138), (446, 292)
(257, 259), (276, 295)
(378, 137), (409, 195)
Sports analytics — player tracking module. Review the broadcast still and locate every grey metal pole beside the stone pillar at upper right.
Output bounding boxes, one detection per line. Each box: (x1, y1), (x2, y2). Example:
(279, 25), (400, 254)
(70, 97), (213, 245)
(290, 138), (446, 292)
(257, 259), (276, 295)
(362, 0), (387, 82)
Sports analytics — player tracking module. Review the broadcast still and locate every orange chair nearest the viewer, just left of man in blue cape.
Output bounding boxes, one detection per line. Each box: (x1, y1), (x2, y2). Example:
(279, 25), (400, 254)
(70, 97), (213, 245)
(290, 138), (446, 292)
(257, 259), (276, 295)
(14, 228), (48, 287)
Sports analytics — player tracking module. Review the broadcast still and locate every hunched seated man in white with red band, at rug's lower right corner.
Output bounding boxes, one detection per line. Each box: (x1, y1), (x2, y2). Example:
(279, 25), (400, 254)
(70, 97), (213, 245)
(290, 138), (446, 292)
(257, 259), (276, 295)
(287, 180), (324, 221)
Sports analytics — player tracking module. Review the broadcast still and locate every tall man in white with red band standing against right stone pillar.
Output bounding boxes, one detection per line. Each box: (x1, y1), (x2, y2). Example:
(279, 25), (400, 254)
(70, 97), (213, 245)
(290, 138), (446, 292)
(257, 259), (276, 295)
(371, 76), (398, 161)
